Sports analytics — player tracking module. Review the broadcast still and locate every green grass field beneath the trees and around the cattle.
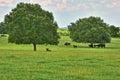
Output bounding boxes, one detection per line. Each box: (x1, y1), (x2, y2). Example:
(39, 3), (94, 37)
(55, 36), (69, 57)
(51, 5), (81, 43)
(0, 36), (120, 80)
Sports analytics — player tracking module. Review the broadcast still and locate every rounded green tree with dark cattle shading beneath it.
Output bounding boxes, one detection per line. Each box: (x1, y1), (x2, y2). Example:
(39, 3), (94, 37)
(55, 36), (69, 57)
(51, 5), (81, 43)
(68, 16), (111, 43)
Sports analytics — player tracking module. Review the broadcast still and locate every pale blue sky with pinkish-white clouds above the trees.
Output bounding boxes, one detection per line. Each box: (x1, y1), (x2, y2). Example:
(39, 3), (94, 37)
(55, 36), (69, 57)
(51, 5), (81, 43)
(0, 0), (120, 27)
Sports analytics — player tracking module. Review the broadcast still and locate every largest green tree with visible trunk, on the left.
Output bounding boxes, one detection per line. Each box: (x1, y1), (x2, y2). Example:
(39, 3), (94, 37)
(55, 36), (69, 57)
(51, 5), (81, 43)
(4, 3), (59, 51)
